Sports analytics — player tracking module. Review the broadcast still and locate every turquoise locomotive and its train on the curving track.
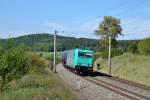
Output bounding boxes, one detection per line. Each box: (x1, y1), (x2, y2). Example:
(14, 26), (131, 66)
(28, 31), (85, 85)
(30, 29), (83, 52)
(62, 49), (94, 74)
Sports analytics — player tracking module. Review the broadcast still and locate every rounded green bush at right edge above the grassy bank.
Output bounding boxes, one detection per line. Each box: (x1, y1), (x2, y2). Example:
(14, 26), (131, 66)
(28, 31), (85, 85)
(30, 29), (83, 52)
(138, 38), (150, 55)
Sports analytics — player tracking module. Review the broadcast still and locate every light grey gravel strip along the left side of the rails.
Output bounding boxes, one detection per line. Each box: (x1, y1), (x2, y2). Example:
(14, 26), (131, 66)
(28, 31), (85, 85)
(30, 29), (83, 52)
(57, 64), (129, 100)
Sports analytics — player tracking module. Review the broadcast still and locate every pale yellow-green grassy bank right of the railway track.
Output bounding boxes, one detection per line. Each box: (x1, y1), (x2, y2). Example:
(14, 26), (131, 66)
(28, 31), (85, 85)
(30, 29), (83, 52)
(94, 53), (150, 85)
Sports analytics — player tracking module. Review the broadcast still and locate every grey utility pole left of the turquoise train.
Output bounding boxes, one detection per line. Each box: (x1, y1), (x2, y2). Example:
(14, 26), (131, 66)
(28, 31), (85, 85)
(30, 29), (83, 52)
(53, 31), (57, 73)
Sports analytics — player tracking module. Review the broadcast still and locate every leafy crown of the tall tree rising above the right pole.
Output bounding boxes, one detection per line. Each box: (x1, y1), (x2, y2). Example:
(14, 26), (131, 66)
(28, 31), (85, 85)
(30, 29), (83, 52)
(95, 16), (122, 46)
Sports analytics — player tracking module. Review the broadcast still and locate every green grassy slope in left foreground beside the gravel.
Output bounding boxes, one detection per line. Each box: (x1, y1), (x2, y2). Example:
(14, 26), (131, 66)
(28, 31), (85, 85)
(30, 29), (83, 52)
(0, 53), (76, 100)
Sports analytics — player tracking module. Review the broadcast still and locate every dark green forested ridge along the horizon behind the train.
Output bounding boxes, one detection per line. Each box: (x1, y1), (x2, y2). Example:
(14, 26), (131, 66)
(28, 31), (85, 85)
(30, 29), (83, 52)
(0, 33), (143, 52)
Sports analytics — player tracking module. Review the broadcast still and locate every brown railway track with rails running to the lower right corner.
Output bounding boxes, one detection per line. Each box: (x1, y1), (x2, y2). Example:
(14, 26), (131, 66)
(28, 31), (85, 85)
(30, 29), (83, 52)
(61, 63), (150, 100)
